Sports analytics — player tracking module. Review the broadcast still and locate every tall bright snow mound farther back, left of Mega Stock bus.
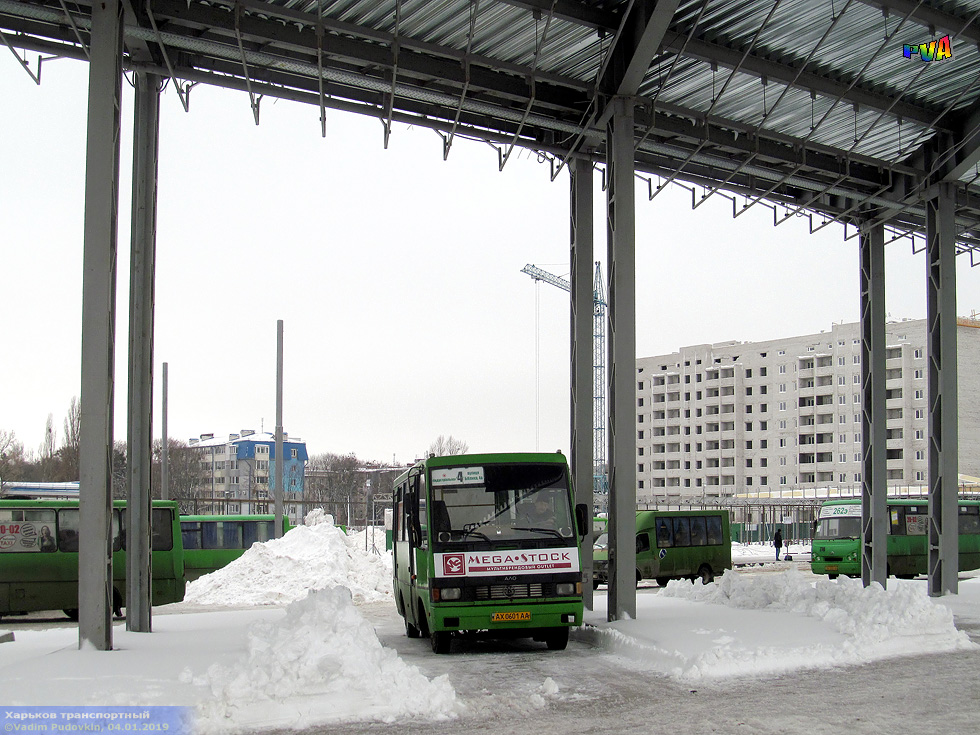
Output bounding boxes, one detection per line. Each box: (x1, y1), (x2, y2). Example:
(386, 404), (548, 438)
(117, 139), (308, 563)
(184, 509), (392, 605)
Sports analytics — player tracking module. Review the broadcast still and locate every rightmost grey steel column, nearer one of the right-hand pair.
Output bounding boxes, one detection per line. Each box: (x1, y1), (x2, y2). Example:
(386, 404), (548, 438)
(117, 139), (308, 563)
(926, 183), (959, 597)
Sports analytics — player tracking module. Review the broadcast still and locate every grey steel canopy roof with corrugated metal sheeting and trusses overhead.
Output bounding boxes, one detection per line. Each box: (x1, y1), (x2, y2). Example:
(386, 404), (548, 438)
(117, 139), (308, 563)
(0, 0), (980, 247)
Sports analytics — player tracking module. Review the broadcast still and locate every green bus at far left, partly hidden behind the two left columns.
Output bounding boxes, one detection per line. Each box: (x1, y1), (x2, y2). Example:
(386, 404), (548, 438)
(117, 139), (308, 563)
(0, 500), (184, 620)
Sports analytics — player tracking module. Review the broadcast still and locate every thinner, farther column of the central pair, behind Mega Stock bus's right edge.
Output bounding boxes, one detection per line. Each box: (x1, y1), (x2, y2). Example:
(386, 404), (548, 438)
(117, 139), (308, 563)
(568, 158), (595, 610)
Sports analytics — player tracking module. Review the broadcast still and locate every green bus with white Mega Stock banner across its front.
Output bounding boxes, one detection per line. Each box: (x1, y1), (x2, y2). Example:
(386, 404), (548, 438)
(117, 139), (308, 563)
(392, 453), (589, 654)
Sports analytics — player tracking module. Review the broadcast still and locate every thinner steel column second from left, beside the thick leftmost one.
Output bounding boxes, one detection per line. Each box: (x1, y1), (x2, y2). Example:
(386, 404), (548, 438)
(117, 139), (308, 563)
(126, 72), (160, 633)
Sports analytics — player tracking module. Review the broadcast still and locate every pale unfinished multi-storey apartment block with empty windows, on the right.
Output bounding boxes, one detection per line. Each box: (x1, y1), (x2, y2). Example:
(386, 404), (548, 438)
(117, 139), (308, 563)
(636, 319), (980, 503)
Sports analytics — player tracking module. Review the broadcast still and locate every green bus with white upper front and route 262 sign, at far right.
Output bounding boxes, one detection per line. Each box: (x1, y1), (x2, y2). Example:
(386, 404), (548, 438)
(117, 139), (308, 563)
(810, 498), (980, 579)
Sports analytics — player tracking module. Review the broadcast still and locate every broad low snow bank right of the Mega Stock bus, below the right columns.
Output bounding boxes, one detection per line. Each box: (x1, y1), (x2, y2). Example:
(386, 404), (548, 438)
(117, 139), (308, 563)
(576, 569), (976, 681)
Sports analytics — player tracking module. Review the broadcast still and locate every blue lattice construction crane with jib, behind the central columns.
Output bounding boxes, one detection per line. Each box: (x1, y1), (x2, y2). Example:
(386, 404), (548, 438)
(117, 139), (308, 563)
(521, 262), (609, 510)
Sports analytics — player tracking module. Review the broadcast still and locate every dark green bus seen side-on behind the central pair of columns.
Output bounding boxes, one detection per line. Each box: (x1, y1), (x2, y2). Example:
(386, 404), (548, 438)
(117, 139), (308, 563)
(592, 509), (732, 587)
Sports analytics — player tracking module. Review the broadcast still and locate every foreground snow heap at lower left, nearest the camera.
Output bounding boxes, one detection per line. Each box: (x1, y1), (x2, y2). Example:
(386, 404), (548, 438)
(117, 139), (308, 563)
(191, 587), (457, 734)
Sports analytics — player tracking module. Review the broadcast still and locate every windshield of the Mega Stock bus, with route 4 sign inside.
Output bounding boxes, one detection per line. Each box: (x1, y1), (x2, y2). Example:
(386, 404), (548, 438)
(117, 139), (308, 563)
(430, 464), (576, 543)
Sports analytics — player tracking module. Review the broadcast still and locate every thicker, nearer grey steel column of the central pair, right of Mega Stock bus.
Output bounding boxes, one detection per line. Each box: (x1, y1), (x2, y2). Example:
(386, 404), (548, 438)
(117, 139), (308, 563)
(606, 97), (636, 621)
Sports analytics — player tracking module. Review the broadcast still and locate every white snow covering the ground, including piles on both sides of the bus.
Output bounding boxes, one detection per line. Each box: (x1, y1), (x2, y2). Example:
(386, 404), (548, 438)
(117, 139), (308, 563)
(0, 516), (980, 733)
